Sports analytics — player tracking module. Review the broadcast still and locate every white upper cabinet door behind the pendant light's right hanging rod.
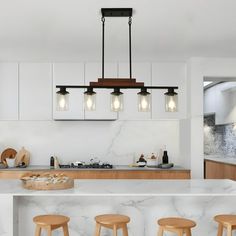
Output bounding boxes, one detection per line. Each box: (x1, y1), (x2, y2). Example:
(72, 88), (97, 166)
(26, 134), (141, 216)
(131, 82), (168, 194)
(119, 63), (151, 120)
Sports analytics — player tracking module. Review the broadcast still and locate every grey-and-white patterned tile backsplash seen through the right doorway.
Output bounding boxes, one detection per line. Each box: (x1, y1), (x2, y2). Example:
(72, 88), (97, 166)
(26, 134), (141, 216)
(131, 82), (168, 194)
(204, 115), (236, 158)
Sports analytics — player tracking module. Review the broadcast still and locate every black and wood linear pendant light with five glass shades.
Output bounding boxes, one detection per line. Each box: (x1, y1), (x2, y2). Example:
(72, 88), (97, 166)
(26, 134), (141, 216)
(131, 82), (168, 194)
(56, 8), (178, 112)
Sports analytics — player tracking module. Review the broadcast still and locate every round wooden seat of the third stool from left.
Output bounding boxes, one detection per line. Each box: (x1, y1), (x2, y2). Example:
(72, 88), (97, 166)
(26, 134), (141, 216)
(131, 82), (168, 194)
(158, 217), (196, 229)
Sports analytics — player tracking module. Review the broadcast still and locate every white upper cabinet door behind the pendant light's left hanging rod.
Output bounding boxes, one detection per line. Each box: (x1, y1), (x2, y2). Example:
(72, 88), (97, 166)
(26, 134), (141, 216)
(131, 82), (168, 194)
(85, 63), (117, 120)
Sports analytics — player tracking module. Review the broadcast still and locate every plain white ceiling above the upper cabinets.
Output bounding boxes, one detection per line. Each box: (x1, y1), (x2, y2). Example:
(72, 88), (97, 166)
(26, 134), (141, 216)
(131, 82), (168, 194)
(0, 0), (236, 61)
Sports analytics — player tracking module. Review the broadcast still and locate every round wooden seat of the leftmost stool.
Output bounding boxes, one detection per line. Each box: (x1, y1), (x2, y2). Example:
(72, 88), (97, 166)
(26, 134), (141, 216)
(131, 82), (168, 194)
(33, 215), (70, 226)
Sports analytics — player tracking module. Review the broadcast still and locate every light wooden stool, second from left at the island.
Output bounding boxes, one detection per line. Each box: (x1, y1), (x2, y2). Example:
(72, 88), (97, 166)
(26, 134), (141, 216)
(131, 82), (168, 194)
(95, 215), (130, 236)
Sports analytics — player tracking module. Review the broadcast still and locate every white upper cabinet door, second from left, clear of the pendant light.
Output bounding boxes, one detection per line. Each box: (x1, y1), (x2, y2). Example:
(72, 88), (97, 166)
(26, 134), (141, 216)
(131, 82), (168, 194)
(19, 63), (52, 120)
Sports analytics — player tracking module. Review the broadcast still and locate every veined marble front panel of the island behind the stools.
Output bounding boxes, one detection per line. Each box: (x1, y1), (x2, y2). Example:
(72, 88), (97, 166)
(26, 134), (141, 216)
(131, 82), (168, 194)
(14, 196), (236, 236)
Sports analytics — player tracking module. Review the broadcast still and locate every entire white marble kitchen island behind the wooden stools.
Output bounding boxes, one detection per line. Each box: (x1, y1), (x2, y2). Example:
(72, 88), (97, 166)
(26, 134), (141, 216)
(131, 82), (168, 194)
(0, 180), (236, 236)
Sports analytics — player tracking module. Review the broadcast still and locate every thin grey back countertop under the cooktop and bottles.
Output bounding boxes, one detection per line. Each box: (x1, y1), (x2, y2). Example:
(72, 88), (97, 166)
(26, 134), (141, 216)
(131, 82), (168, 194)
(0, 165), (189, 171)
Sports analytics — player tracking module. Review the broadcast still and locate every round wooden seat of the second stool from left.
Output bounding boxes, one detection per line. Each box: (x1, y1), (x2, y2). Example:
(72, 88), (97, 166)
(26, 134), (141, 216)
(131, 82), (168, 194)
(95, 214), (130, 225)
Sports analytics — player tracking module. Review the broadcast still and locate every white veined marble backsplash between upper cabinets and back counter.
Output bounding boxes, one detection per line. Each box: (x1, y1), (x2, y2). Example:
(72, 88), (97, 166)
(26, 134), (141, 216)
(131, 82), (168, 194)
(0, 120), (179, 165)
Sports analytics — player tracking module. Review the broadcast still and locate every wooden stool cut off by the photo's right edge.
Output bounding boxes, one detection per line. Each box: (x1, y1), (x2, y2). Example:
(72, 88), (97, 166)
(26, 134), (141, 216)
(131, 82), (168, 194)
(214, 215), (236, 236)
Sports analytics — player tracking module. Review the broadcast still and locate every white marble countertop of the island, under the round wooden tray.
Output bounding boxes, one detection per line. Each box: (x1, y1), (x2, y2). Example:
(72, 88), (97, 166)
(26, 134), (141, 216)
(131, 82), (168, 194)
(0, 180), (236, 197)
